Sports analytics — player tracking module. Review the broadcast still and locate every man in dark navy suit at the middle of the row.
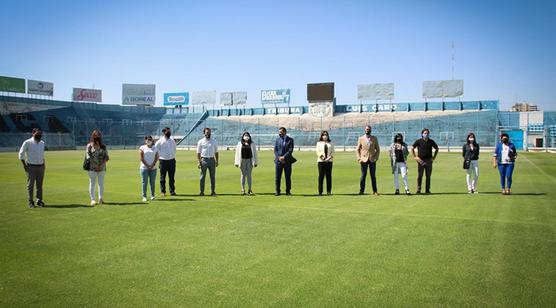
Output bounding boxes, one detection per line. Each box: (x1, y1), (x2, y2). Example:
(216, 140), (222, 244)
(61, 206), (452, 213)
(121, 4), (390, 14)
(274, 127), (295, 196)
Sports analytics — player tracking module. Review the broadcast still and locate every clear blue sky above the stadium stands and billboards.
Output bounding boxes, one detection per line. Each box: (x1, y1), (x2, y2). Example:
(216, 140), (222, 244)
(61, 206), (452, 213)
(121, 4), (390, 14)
(0, 0), (556, 110)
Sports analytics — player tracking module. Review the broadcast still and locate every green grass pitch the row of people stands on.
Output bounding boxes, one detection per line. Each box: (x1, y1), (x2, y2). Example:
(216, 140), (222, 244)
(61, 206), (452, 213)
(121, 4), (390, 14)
(0, 151), (556, 307)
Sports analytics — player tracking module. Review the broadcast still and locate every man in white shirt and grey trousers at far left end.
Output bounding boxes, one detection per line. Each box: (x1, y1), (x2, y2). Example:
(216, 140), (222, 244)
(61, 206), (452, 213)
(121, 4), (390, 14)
(19, 128), (46, 209)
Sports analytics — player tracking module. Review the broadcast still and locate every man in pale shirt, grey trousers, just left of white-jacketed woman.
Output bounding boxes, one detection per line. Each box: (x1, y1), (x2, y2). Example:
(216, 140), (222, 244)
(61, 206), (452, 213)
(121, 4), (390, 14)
(197, 127), (218, 196)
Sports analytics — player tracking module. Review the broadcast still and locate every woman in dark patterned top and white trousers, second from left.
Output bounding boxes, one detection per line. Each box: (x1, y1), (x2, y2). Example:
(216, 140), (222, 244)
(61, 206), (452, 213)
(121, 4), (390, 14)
(86, 129), (109, 206)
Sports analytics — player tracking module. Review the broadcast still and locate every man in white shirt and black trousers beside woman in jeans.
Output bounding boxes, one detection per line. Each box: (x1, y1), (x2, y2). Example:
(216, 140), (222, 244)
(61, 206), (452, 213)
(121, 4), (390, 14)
(155, 127), (176, 196)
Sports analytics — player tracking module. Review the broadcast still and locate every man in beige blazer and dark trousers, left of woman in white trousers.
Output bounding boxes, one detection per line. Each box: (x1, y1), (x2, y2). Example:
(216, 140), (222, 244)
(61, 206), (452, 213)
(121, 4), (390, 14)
(356, 125), (380, 196)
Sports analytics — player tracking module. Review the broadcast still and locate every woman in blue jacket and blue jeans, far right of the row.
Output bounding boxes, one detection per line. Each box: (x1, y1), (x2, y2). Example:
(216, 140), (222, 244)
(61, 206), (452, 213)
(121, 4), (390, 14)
(492, 133), (517, 195)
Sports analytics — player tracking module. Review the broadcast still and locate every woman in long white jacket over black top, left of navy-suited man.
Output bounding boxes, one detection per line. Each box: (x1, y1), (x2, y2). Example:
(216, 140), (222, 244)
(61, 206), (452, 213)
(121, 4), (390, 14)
(234, 132), (257, 195)
